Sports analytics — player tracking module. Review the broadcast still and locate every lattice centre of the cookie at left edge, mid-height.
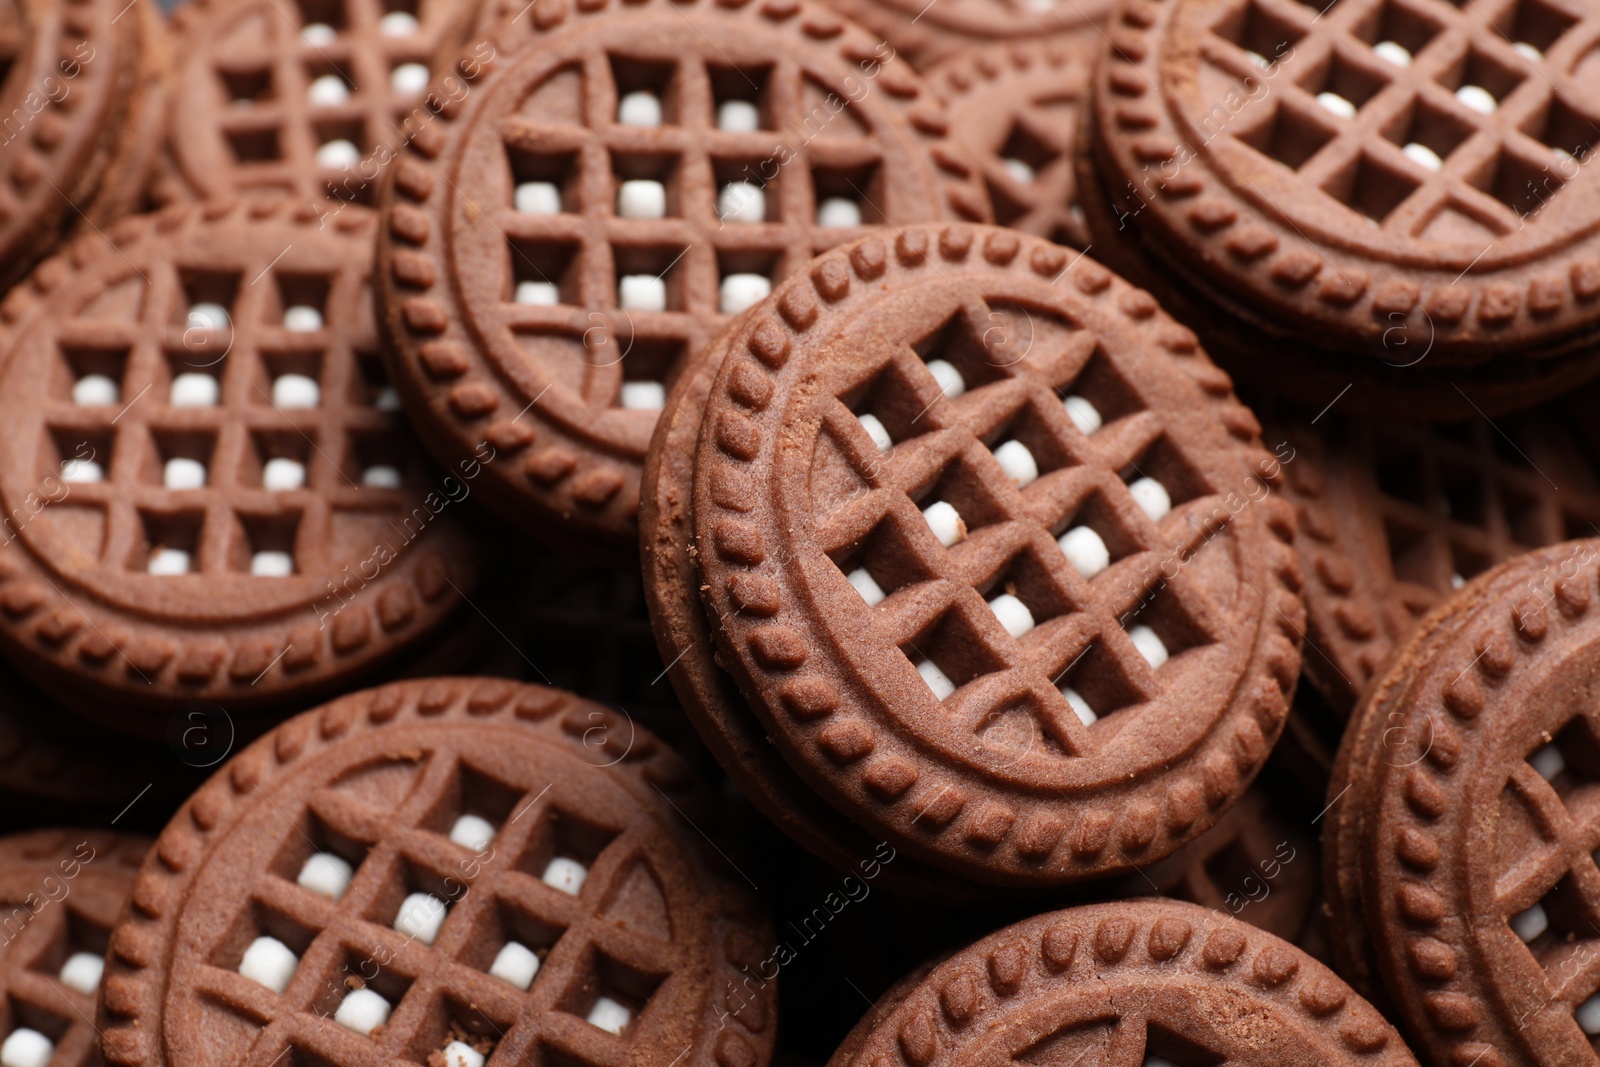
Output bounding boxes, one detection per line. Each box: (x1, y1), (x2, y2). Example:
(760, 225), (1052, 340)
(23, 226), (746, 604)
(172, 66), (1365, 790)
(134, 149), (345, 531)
(35, 230), (410, 579)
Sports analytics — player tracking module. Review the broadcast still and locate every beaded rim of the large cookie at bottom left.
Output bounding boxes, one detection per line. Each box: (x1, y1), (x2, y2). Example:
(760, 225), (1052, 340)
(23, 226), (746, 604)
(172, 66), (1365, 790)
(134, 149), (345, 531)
(98, 678), (778, 1067)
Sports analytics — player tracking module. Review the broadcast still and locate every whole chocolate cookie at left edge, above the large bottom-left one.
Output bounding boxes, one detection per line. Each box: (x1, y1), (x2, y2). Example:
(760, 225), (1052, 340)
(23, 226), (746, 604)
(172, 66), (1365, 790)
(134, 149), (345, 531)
(0, 202), (482, 736)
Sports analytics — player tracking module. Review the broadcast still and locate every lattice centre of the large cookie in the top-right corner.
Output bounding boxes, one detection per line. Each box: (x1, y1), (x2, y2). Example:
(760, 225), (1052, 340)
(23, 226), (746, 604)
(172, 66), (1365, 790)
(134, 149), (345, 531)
(1202, 0), (1600, 242)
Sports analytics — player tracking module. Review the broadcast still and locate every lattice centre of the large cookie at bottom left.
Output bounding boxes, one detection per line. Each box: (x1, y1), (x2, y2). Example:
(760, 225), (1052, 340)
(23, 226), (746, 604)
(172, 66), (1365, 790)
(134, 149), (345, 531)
(174, 745), (683, 1067)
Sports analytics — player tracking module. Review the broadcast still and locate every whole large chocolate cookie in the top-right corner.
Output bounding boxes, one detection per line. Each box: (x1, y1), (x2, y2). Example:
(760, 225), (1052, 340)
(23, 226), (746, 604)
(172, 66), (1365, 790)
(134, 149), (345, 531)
(1093, 0), (1600, 368)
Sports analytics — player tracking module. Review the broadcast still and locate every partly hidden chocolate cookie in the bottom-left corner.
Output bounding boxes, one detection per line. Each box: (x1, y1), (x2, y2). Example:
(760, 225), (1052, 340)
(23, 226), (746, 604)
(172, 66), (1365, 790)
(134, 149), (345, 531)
(0, 829), (150, 1067)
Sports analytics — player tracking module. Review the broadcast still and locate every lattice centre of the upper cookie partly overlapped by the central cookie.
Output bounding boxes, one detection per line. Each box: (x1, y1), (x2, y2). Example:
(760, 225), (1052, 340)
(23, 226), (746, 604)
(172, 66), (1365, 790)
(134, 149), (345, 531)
(488, 40), (894, 426)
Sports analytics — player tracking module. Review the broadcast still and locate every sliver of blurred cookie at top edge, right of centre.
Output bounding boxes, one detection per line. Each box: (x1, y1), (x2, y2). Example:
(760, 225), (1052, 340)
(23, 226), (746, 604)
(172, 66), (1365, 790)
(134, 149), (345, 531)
(812, 0), (1115, 70)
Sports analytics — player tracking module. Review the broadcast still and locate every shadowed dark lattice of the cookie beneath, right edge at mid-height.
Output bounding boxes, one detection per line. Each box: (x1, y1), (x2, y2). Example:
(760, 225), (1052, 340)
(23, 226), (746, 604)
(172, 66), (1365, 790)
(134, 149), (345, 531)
(1347, 421), (1600, 616)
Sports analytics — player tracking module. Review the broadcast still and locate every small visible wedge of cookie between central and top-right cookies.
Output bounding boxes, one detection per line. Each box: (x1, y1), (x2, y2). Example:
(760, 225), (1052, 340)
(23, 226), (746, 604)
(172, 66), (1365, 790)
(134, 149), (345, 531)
(928, 32), (1099, 248)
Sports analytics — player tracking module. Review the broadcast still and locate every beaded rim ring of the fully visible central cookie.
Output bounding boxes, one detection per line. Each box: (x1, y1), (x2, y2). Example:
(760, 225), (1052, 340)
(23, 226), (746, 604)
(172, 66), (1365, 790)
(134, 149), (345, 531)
(694, 226), (1304, 885)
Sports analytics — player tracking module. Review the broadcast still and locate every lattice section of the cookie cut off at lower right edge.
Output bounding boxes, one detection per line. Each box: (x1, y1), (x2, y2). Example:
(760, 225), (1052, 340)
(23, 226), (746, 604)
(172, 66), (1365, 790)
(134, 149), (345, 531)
(1494, 717), (1600, 1035)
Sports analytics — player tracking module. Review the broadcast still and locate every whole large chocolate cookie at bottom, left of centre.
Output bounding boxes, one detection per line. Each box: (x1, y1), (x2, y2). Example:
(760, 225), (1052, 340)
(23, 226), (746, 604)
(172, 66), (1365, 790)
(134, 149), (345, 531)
(101, 678), (776, 1067)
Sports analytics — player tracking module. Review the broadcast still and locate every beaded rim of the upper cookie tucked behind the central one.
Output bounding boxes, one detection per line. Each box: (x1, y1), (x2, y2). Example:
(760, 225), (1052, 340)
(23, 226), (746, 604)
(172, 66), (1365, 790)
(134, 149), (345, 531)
(376, 0), (989, 544)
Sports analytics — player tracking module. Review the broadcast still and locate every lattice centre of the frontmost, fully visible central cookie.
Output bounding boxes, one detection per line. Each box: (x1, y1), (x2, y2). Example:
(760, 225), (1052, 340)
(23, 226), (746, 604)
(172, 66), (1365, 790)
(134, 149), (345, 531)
(811, 295), (1221, 755)
